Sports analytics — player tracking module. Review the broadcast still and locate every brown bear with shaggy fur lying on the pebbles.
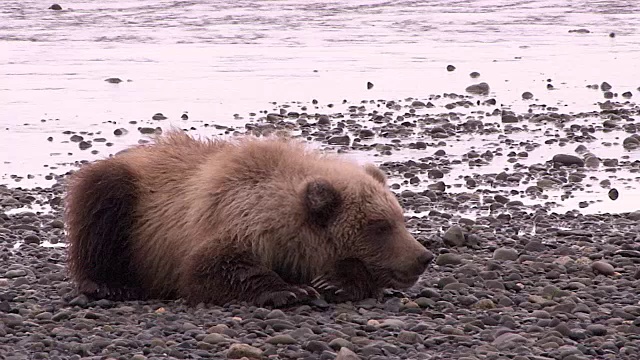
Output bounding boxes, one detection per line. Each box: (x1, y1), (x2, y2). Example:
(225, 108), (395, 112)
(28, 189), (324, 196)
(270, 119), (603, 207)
(65, 130), (433, 306)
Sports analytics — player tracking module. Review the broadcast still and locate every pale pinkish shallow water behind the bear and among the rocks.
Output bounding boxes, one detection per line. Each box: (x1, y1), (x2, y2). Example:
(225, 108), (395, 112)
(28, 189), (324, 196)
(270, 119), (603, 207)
(0, 0), (640, 215)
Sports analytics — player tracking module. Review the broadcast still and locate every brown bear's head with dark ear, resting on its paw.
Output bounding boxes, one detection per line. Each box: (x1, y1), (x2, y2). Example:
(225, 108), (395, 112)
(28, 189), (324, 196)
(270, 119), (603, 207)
(304, 164), (433, 296)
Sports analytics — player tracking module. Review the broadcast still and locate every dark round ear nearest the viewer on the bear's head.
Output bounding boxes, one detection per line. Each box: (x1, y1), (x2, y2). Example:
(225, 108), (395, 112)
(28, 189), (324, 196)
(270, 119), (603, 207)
(304, 179), (342, 227)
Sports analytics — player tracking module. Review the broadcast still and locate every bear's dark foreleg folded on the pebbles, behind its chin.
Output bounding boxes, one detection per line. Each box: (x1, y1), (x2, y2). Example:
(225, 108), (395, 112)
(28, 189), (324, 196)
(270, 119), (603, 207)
(180, 249), (319, 307)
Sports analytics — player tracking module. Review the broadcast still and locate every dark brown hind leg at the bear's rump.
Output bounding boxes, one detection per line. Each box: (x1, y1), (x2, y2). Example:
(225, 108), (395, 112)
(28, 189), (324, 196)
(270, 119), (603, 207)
(65, 160), (144, 300)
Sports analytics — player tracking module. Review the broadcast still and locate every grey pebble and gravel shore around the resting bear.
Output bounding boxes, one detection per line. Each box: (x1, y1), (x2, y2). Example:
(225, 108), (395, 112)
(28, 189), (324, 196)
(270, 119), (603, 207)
(0, 86), (640, 360)
